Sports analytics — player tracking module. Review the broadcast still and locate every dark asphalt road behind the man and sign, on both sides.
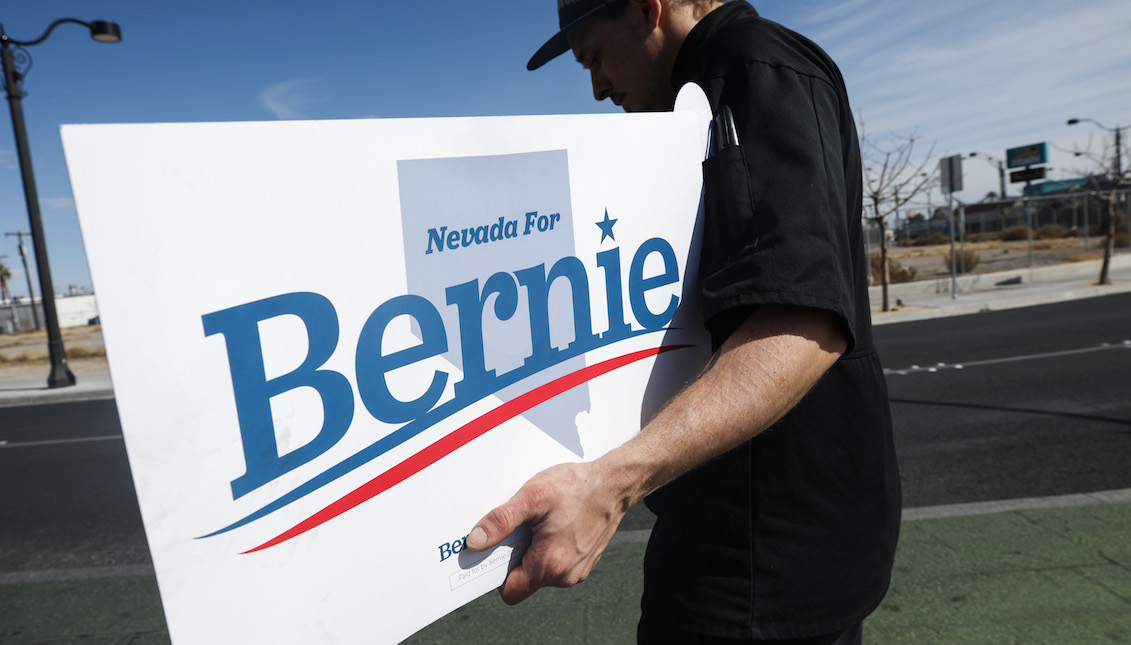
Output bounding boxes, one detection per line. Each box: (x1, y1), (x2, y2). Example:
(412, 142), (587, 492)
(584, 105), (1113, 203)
(0, 295), (1131, 571)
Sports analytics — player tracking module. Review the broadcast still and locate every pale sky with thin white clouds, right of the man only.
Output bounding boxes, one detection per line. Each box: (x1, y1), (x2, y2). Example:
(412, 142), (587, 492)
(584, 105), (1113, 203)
(783, 0), (1131, 201)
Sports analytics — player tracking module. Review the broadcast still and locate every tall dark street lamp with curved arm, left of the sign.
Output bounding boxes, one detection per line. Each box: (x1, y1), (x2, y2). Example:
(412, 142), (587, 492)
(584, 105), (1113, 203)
(0, 18), (122, 388)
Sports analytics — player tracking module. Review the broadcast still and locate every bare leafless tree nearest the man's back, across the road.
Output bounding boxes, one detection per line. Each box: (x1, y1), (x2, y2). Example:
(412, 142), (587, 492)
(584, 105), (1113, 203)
(860, 124), (938, 311)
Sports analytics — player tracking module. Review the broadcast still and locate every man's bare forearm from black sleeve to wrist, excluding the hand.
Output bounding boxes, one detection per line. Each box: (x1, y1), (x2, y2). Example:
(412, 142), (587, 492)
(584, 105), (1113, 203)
(595, 307), (846, 506)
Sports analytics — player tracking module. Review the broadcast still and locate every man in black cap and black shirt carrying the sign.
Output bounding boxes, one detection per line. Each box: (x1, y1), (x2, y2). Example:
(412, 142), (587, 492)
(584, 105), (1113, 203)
(468, 0), (899, 643)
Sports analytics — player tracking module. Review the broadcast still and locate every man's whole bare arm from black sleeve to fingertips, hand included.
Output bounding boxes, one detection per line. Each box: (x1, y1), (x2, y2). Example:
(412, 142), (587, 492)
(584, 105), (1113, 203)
(467, 307), (845, 603)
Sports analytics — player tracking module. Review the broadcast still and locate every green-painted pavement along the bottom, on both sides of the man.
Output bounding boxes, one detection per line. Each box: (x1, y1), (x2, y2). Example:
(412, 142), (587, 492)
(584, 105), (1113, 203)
(0, 502), (1131, 645)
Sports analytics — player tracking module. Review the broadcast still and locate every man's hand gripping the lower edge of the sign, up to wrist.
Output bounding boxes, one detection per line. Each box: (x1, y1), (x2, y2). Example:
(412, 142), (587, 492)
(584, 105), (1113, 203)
(467, 461), (628, 604)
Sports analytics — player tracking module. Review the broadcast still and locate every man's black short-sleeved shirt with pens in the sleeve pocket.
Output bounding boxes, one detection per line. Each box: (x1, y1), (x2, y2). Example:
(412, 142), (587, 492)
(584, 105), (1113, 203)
(642, 0), (900, 638)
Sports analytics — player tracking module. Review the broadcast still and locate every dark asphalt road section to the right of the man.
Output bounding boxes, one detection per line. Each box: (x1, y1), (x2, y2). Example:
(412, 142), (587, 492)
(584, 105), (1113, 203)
(877, 294), (1131, 507)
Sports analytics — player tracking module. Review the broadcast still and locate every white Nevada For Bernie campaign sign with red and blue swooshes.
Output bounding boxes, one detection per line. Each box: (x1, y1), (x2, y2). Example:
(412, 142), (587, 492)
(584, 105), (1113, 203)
(62, 87), (710, 645)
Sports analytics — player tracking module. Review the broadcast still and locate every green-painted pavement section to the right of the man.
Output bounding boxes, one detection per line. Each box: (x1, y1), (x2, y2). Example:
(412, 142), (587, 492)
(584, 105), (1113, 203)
(865, 504), (1131, 645)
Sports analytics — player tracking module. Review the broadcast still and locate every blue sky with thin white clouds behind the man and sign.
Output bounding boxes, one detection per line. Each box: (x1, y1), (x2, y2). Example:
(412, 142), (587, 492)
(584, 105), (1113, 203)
(0, 0), (1131, 295)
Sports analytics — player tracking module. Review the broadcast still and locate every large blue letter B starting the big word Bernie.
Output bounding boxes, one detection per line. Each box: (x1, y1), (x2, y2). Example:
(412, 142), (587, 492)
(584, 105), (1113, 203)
(202, 293), (354, 499)
